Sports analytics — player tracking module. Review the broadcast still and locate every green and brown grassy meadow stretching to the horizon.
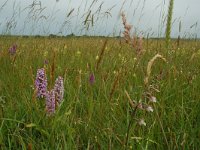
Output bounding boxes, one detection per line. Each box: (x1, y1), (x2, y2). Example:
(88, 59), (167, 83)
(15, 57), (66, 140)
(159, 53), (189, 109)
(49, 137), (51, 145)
(0, 37), (200, 150)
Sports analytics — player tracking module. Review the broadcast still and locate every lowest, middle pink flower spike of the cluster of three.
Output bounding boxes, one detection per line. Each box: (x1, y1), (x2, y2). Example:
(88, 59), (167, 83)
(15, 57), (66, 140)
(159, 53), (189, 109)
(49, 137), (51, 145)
(46, 89), (56, 115)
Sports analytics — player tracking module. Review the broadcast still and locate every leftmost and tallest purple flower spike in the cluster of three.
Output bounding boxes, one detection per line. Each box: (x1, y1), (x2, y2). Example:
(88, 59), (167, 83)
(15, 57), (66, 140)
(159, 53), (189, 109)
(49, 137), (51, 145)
(35, 68), (47, 98)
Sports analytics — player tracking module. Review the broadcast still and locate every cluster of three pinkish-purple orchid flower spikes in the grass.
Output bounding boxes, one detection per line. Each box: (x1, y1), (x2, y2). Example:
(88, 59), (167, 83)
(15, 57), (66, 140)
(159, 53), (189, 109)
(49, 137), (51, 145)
(35, 68), (64, 115)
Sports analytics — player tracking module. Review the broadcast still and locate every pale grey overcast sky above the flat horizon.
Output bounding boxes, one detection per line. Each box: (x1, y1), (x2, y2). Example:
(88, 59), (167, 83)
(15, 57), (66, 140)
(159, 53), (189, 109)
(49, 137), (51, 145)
(0, 0), (200, 38)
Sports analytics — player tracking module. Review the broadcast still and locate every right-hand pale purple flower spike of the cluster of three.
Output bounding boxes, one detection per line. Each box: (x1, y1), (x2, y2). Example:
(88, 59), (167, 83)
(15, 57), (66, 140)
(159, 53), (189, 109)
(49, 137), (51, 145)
(54, 76), (64, 104)
